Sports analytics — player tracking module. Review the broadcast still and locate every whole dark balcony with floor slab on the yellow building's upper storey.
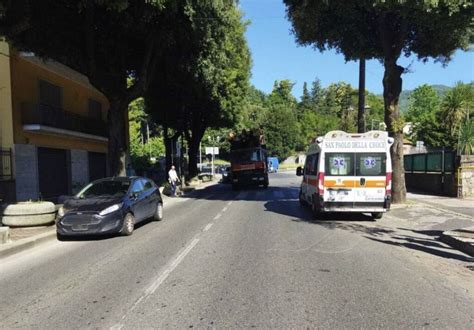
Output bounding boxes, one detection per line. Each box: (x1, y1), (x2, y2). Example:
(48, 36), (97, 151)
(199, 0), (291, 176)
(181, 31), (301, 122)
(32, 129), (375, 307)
(21, 103), (107, 141)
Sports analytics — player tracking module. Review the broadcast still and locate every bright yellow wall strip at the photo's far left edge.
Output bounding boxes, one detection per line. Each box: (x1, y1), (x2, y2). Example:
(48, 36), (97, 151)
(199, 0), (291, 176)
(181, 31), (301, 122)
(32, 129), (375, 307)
(0, 40), (13, 148)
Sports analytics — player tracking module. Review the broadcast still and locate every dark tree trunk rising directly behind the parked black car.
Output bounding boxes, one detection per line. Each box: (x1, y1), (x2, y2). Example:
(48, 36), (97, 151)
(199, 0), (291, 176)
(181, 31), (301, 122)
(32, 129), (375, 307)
(107, 98), (128, 176)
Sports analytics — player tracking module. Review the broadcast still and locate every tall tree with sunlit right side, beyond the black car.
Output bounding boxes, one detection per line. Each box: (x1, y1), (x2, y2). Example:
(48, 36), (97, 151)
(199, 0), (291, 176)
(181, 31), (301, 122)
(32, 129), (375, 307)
(146, 0), (250, 177)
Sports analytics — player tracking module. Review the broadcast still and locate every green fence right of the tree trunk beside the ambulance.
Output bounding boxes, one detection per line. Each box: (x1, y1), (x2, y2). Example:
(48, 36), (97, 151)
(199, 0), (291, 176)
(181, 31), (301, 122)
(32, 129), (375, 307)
(403, 150), (457, 196)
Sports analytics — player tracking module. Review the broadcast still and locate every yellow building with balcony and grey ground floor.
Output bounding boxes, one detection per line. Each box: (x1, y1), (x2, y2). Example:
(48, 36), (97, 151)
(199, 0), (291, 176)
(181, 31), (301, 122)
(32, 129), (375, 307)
(0, 40), (118, 201)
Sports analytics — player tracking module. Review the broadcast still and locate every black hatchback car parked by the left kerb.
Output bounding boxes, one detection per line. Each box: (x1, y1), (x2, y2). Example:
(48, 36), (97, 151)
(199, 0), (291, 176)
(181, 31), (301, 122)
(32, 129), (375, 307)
(56, 177), (163, 238)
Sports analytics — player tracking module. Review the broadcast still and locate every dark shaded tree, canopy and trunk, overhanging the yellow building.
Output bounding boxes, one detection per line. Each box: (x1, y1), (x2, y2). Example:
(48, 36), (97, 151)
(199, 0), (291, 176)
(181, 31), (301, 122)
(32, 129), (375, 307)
(0, 0), (174, 175)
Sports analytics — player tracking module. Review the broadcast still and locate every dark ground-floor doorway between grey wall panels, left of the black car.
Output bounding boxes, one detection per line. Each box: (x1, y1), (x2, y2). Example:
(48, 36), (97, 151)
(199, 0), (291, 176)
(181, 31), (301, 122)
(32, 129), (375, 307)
(38, 147), (69, 201)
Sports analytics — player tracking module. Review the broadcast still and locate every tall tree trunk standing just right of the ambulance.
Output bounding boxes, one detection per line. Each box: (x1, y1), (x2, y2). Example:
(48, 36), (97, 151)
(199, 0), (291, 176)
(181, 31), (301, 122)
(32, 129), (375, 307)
(383, 59), (407, 203)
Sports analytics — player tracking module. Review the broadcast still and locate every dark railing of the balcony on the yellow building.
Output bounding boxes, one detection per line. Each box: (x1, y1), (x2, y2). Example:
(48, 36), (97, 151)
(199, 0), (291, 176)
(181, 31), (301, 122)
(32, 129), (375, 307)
(21, 103), (107, 137)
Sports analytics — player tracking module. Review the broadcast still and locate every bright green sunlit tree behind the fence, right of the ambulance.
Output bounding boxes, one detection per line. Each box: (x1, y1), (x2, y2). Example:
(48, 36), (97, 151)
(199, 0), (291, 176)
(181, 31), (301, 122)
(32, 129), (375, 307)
(405, 84), (446, 147)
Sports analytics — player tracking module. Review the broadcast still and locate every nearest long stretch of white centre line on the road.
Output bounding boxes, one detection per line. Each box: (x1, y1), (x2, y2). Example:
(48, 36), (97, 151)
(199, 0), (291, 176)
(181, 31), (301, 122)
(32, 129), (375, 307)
(110, 236), (201, 330)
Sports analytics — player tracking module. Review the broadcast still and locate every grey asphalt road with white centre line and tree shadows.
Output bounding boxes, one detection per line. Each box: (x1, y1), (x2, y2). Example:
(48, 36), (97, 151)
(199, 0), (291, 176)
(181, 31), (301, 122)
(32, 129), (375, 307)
(0, 172), (474, 329)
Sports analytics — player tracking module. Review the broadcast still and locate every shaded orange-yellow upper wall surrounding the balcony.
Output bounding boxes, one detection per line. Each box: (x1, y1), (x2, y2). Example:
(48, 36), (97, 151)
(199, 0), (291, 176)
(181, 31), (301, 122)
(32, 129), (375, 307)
(11, 52), (109, 152)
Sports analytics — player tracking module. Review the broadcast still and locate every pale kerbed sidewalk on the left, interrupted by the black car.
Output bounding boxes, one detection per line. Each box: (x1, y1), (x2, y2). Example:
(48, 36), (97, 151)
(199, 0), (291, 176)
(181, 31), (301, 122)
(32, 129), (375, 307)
(0, 180), (218, 259)
